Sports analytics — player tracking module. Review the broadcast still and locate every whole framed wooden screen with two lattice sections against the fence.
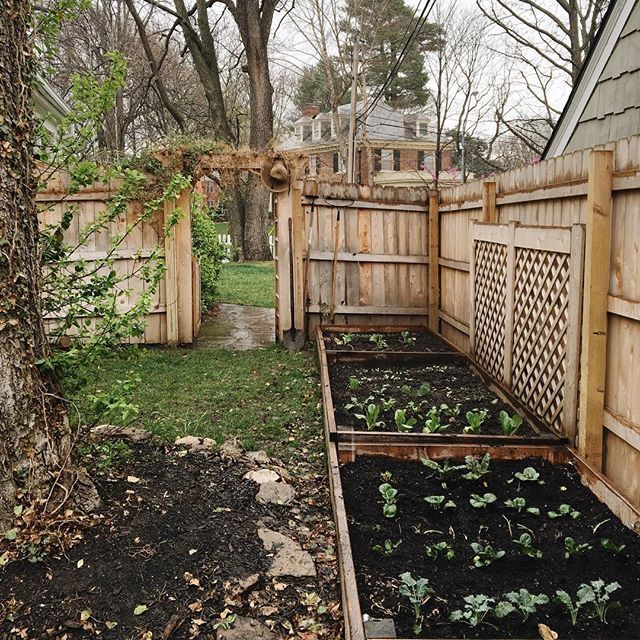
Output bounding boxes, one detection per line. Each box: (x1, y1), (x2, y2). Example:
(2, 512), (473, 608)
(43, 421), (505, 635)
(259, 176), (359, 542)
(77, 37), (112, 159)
(470, 222), (584, 440)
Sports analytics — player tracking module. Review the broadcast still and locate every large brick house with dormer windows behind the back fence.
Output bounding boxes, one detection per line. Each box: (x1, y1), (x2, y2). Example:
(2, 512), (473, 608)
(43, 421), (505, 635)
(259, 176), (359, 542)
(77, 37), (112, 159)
(282, 103), (458, 186)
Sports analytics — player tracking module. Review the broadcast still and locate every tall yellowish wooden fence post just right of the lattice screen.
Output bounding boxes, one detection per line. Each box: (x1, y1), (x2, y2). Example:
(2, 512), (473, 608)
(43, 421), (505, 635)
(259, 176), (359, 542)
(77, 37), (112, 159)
(578, 150), (613, 470)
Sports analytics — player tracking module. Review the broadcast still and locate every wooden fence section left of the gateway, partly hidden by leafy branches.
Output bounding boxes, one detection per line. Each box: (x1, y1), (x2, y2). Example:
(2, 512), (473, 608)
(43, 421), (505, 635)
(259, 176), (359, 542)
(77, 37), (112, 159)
(36, 173), (195, 345)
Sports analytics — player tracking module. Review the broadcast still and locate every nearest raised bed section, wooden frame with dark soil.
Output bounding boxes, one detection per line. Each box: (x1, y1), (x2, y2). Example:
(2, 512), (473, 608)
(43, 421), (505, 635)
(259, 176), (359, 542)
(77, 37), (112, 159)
(329, 443), (640, 640)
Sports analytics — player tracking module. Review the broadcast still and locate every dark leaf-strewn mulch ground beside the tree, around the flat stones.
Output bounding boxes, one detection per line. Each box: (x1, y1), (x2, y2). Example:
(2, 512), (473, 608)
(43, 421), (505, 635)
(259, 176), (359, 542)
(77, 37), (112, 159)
(0, 445), (340, 640)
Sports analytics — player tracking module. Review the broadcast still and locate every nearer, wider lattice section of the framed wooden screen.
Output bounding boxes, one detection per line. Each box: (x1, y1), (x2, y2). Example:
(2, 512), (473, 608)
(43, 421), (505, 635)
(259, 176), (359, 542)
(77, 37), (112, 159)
(512, 248), (570, 432)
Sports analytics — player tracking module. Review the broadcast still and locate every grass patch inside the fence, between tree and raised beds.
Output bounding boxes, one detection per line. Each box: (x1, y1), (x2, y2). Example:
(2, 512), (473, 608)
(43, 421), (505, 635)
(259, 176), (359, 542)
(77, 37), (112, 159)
(72, 345), (322, 460)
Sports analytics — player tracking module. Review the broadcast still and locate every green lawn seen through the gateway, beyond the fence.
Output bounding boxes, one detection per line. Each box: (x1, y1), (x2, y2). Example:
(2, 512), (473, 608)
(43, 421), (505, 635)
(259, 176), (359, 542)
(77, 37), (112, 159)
(218, 260), (275, 308)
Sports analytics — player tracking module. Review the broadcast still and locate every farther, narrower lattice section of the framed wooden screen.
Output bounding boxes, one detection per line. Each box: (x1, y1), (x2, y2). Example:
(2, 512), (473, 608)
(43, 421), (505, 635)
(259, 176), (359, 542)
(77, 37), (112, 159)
(475, 241), (507, 380)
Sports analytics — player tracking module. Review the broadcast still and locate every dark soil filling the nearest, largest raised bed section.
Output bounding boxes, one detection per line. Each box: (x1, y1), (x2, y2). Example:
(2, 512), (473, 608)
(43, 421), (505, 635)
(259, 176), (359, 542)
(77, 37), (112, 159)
(342, 457), (640, 640)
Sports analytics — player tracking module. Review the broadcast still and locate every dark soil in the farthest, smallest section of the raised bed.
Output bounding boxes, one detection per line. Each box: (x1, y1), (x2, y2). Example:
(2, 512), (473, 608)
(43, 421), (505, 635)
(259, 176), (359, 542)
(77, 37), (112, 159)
(324, 331), (452, 353)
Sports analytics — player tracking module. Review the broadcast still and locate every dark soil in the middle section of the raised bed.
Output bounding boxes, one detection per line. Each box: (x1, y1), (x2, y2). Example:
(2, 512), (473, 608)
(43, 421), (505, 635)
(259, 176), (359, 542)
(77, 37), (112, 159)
(329, 362), (537, 437)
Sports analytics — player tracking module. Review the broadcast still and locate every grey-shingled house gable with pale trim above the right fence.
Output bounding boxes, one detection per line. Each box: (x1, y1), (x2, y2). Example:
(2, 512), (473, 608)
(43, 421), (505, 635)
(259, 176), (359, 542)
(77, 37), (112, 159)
(542, 0), (640, 158)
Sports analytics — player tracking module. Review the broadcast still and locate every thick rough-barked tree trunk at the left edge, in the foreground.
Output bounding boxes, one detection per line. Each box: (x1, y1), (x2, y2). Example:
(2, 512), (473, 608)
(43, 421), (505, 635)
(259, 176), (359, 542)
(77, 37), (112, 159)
(0, 0), (79, 531)
